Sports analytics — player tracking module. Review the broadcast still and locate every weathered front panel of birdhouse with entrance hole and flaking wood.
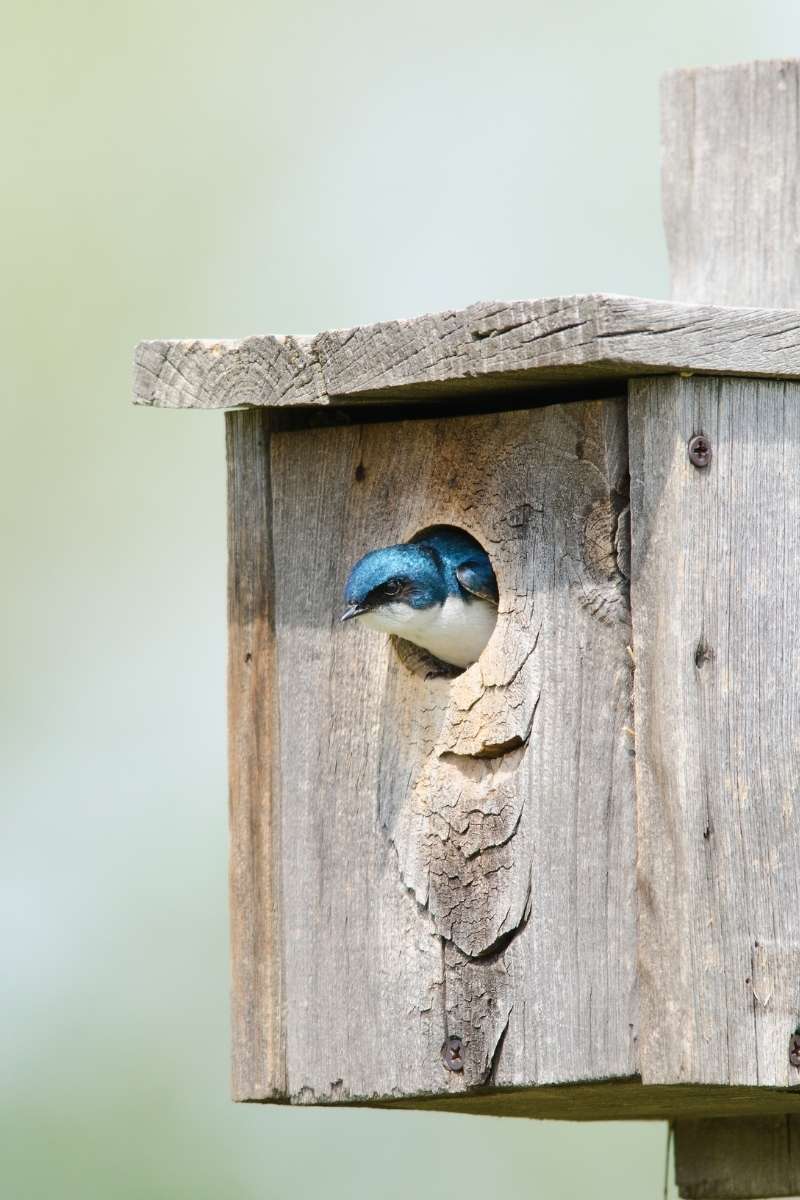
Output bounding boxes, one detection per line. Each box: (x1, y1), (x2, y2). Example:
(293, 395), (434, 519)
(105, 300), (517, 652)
(263, 401), (637, 1103)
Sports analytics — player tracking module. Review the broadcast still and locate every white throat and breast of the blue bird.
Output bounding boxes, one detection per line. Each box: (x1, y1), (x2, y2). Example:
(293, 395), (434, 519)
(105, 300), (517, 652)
(356, 596), (498, 667)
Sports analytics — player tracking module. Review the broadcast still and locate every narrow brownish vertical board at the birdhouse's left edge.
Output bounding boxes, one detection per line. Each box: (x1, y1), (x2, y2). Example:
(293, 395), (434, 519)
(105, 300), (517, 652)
(225, 410), (285, 1099)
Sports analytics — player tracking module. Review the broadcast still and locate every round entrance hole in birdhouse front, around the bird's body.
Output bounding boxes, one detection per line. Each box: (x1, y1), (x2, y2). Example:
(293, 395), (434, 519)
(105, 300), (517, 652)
(391, 524), (498, 679)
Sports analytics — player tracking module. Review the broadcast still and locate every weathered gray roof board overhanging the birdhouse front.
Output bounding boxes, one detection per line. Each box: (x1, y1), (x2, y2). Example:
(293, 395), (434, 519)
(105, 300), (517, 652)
(134, 295), (800, 408)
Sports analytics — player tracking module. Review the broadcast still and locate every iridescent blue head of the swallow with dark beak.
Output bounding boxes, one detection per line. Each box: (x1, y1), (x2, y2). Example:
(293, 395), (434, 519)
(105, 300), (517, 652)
(342, 544), (447, 620)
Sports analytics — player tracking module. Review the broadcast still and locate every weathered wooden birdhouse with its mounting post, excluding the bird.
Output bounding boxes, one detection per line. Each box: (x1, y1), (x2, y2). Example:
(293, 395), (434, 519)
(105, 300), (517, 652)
(136, 62), (800, 1198)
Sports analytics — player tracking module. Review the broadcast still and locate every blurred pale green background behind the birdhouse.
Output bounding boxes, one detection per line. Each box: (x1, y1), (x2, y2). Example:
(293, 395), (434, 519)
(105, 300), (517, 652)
(0, 0), (800, 1200)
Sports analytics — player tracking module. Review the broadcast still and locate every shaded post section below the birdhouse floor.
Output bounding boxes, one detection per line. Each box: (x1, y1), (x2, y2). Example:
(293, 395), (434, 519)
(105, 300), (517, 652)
(675, 1116), (800, 1200)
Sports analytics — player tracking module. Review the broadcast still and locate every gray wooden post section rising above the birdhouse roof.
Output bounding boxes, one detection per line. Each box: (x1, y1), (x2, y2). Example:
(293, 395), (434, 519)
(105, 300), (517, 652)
(662, 60), (800, 307)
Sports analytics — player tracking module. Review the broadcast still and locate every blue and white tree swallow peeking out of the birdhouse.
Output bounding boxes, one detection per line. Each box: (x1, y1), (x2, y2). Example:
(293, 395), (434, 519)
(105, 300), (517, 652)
(342, 526), (498, 667)
